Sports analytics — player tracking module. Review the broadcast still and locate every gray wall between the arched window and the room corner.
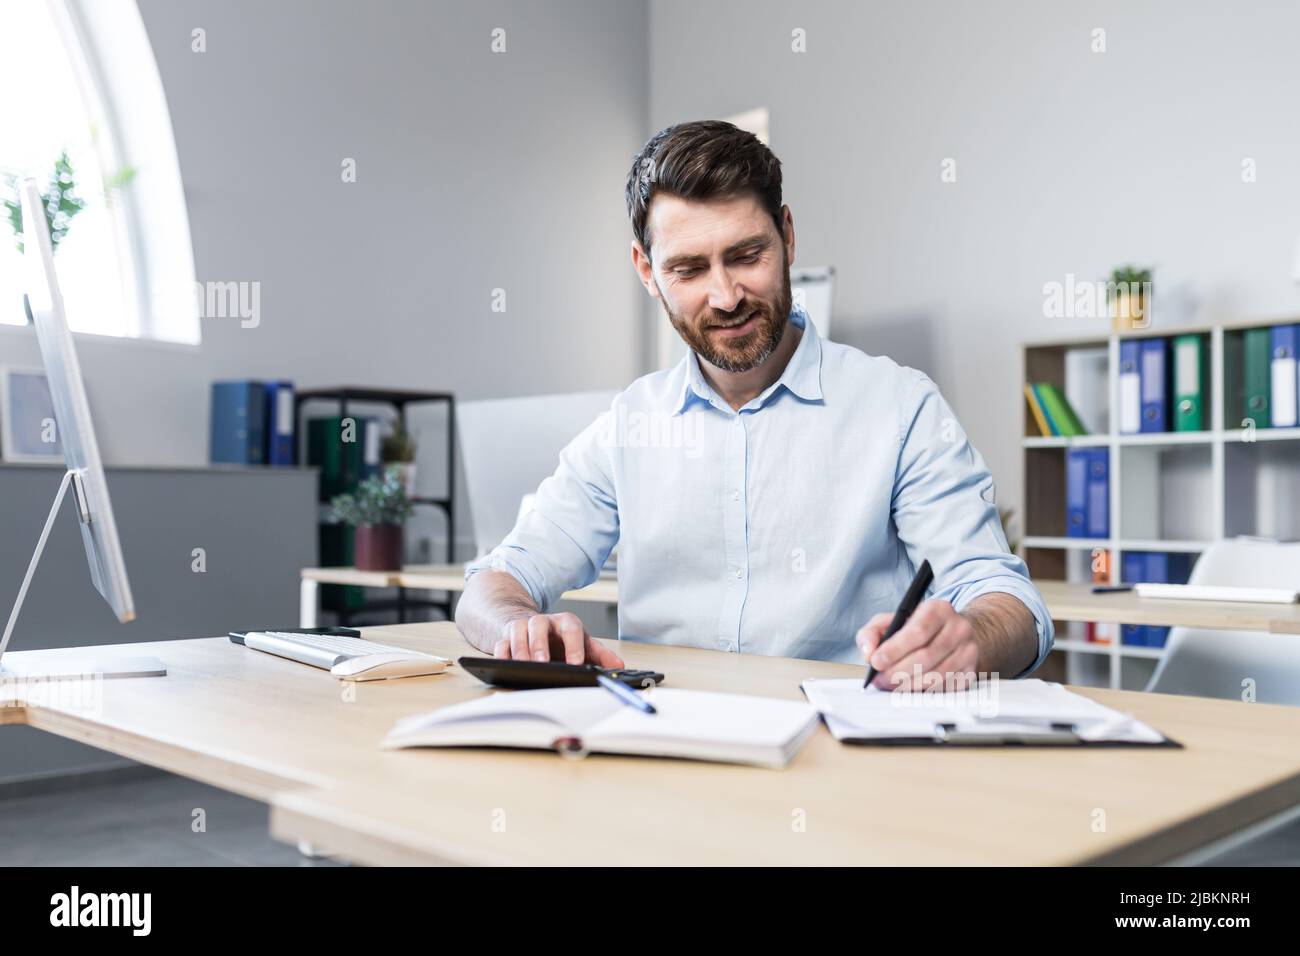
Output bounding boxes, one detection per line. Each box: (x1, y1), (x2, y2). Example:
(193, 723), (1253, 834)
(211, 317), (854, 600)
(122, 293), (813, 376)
(0, 0), (646, 561)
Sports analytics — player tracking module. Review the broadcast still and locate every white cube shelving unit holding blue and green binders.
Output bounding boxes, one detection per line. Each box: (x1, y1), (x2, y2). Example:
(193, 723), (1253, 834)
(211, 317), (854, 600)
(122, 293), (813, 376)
(1019, 319), (1300, 688)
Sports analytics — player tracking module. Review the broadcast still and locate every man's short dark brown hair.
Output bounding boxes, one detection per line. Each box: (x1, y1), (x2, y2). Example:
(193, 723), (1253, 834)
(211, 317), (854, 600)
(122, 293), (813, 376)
(627, 120), (783, 256)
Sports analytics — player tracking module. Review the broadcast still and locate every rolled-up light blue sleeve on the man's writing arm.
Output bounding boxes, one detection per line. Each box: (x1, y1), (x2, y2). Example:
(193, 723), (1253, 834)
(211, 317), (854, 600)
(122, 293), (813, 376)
(893, 372), (1053, 676)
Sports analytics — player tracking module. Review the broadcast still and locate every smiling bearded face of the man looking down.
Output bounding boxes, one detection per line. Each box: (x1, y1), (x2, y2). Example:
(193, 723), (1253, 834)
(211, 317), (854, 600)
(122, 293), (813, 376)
(632, 195), (794, 372)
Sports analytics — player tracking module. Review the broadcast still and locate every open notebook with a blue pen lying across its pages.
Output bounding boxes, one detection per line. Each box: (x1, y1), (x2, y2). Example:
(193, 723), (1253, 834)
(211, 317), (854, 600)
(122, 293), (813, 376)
(384, 687), (818, 767)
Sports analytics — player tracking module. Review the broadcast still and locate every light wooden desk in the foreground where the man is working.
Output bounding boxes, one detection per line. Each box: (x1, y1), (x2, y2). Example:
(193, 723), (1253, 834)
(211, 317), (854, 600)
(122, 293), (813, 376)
(0, 623), (1300, 866)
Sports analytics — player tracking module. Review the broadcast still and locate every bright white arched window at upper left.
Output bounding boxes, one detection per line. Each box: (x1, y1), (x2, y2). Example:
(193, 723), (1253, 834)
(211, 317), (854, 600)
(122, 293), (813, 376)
(0, 0), (199, 343)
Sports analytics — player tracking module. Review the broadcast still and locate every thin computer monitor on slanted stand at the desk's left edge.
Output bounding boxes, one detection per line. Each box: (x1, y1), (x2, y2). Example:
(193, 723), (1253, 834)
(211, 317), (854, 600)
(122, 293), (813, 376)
(0, 178), (161, 676)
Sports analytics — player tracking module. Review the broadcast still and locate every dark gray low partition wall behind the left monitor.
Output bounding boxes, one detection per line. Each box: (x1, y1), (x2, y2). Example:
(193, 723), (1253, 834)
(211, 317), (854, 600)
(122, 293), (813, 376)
(0, 464), (316, 782)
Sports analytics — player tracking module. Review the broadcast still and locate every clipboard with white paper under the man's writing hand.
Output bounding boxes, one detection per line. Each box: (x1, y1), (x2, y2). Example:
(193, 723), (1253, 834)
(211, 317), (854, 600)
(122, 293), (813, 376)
(801, 679), (1179, 747)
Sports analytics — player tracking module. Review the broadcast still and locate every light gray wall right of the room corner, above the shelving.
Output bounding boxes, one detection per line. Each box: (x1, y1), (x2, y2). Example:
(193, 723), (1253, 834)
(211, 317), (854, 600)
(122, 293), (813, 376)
(650, 0), (1300, 515)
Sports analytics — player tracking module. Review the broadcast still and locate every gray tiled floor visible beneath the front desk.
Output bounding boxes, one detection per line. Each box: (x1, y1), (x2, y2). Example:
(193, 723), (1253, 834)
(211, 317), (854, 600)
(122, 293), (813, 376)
(0, 773), (1300, 866)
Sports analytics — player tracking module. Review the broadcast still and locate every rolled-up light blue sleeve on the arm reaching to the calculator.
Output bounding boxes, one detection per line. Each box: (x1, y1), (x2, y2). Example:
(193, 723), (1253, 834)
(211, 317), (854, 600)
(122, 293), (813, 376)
(465, 411), (619, 613)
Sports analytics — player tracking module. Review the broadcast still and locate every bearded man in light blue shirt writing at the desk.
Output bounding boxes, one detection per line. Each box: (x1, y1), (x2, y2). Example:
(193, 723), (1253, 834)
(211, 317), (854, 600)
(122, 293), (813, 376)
(456, 121), (1052, 689)
